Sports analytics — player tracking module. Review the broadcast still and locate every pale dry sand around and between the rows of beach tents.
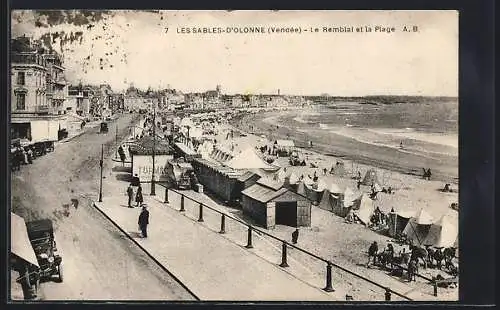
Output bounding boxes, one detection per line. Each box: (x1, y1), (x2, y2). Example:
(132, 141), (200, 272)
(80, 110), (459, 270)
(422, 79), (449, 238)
(205, 116), (458, 300)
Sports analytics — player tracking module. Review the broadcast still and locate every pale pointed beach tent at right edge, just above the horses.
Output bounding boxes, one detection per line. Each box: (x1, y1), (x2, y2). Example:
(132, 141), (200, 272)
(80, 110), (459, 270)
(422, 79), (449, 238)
(422, 215), (458, 248)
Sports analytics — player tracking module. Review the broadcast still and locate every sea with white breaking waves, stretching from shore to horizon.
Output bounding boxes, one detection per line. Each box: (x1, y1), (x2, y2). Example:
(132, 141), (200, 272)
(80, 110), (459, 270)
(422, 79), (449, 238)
(256, 99), (459, 179)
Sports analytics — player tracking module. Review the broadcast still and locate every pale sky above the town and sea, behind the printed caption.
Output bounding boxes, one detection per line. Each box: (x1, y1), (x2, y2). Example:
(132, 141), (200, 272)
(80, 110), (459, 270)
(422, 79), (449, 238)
(11, 11), (458, 96)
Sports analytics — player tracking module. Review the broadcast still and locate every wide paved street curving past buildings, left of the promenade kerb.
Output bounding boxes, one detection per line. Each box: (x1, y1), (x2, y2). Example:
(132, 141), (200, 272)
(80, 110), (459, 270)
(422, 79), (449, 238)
(11, 114), (194, 300)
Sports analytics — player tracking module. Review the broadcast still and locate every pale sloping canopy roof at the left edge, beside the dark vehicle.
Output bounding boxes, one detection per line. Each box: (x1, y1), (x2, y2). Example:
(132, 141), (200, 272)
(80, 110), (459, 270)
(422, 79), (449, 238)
(10, 212), (38, 266)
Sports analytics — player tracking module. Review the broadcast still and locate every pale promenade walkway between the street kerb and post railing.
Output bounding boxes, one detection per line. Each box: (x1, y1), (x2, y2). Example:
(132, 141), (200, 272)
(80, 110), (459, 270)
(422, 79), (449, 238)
(95, 191), (340, 301)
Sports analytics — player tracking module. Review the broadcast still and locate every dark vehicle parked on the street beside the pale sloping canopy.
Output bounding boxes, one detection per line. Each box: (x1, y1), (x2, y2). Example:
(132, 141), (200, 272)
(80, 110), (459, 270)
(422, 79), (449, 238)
(26, 219), (63, 282)
